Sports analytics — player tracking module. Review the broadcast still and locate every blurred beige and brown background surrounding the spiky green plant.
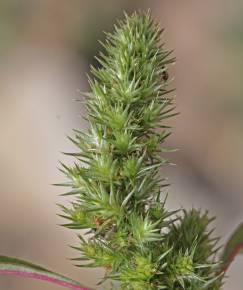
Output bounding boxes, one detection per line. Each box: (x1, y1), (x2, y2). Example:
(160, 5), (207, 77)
(0, 0), (243, 290)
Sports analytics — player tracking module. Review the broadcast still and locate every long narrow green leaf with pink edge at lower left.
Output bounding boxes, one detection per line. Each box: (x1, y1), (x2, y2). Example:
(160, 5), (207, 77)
(0, 256), (91, 290)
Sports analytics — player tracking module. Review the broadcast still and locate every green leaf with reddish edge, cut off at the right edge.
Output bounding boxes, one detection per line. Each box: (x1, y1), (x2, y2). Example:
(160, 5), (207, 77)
(222, 223), (243, 272)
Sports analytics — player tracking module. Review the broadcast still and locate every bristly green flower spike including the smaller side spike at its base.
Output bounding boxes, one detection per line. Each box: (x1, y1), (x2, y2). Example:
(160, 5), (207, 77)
(61, 13), (224, 290)
